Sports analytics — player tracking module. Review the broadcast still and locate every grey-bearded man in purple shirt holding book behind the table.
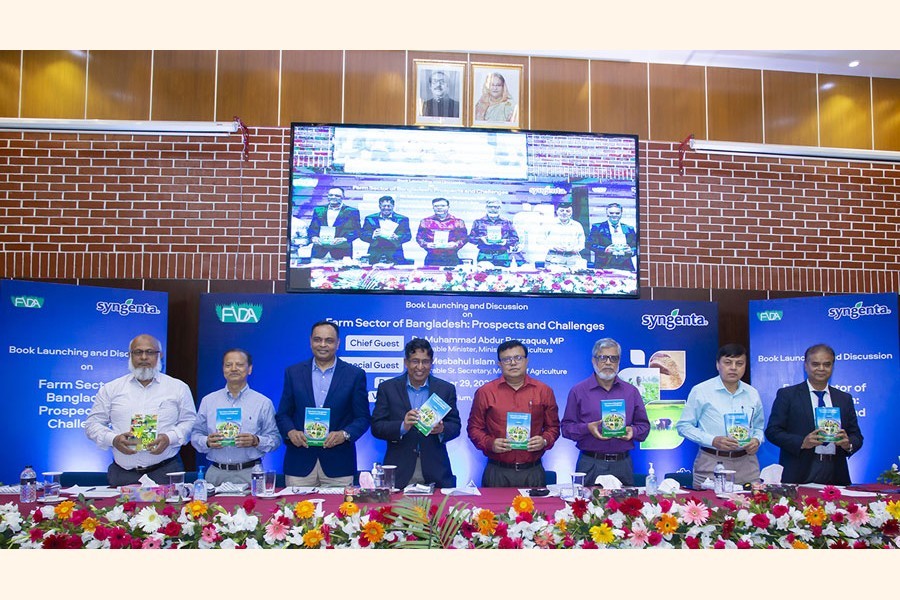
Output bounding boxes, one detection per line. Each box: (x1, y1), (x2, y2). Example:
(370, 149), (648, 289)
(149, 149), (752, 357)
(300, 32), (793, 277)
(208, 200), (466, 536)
(562, 338), (650, 485)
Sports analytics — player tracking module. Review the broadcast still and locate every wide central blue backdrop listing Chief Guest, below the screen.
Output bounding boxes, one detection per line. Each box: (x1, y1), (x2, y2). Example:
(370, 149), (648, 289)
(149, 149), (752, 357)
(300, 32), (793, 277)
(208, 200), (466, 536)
(198, 294), (718, 484)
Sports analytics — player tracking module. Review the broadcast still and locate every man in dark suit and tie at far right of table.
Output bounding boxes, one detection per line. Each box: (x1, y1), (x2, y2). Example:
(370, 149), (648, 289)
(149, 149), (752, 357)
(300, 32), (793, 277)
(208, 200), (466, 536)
(766, 344), (863, 485)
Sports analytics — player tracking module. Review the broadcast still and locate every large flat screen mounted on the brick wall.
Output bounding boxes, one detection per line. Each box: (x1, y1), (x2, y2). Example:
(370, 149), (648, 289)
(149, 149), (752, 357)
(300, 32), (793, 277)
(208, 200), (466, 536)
(287, 123), (640, 297)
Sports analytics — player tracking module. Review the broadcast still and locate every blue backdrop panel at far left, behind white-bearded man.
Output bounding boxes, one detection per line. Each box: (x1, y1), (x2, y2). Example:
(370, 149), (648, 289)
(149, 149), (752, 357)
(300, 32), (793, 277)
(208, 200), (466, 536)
(0, 280), (167, 482)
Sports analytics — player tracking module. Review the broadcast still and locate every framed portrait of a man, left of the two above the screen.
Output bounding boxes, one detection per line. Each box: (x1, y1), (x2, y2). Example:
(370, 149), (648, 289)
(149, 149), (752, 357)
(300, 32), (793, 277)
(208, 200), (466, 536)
(413, 59), (466, 127)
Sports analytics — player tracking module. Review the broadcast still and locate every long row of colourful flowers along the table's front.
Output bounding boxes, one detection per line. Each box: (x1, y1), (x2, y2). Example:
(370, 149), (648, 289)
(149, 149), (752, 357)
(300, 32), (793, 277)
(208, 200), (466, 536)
(0, 487), (900, 549)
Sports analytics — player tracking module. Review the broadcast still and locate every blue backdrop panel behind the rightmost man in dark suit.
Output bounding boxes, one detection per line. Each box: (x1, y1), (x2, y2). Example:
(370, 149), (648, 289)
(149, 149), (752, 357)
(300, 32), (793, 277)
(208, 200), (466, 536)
(750, 294), (900, 482)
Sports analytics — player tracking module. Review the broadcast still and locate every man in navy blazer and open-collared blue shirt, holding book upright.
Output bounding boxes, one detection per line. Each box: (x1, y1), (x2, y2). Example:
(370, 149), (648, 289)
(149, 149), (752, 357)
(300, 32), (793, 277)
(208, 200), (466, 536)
(275, 321), (371, 487)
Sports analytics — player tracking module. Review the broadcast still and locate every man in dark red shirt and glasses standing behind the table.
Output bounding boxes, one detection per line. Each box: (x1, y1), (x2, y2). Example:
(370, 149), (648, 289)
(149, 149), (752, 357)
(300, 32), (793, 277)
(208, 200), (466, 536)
(467, 340), (559, 488)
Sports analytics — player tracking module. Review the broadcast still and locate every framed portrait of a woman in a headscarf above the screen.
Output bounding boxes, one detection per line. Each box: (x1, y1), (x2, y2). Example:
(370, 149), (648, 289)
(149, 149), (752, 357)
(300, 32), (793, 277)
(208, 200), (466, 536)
(469, 63), (525, 129)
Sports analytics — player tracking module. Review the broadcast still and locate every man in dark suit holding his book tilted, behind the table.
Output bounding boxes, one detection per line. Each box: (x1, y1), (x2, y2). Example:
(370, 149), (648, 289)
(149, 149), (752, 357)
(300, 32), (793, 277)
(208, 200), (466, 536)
(372, 338), (461, 488)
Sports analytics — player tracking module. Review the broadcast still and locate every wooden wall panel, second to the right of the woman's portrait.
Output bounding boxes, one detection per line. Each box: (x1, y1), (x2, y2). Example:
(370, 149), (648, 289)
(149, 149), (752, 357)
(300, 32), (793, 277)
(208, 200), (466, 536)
(591, 60), (650, 139)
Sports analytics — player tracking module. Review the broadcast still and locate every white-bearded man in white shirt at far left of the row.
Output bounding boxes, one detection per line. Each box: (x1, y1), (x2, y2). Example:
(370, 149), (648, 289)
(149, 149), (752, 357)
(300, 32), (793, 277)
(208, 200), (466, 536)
(85, 334), (197, 486)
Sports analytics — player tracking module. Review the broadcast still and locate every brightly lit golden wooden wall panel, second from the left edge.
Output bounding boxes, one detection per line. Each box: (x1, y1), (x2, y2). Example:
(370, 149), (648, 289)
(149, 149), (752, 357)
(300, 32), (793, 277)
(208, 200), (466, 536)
(22, 50), (87, 119)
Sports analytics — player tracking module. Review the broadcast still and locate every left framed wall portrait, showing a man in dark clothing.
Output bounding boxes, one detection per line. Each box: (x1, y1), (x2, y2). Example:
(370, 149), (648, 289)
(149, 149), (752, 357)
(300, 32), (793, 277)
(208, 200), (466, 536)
(413, 60), (466, 127)
